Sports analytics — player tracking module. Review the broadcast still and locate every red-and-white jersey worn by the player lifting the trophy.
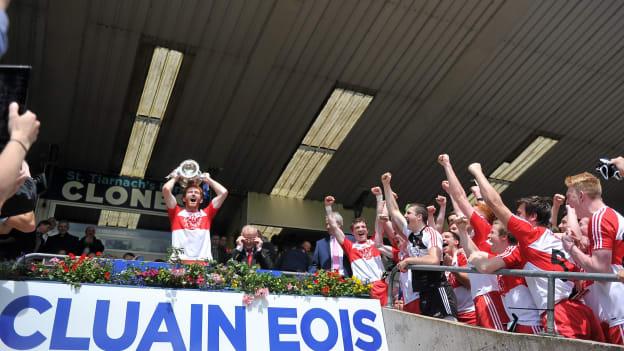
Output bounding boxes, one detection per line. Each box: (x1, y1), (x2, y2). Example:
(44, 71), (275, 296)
(167, 202), (218, 260)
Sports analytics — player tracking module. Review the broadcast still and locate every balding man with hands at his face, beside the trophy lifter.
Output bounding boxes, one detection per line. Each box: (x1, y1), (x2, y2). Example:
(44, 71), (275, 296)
(232, 225), (273, 269)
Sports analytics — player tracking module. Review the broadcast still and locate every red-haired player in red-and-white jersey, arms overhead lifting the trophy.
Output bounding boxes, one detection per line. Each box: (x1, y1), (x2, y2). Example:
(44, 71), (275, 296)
(162, 173), (228, 262)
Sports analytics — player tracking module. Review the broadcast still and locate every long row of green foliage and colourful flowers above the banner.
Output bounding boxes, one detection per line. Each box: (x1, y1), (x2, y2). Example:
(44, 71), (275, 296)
(19, 255), (370, 300)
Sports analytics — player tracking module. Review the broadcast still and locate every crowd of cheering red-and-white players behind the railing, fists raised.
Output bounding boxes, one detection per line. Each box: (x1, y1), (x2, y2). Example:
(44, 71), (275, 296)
(316, 154), (624, 345)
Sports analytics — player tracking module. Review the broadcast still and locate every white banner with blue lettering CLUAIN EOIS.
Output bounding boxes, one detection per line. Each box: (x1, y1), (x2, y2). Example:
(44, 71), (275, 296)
(0, 281), (388, 351)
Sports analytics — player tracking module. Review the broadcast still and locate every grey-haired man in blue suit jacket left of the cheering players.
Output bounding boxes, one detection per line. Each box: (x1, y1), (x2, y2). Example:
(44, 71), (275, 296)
(309, 212), (355, 277)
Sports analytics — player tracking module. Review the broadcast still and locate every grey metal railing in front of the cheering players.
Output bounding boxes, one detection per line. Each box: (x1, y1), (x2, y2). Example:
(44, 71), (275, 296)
(386, 265), (618, 335)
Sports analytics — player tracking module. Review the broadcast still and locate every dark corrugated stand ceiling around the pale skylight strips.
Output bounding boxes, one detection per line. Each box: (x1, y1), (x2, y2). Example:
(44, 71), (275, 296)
(3, 0), (624, 234)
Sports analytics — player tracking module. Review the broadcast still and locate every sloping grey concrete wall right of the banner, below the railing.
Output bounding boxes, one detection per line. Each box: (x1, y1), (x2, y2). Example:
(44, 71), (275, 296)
(383, 308), (624, 351)
